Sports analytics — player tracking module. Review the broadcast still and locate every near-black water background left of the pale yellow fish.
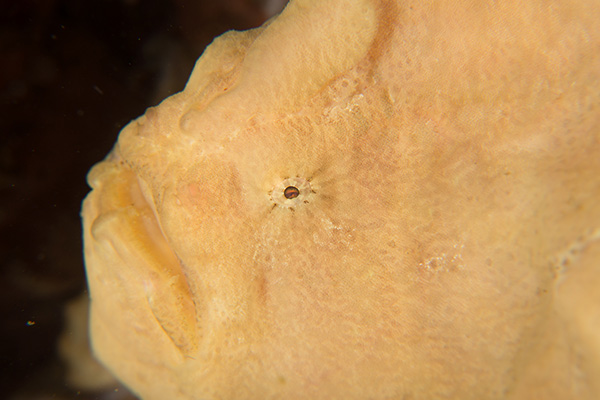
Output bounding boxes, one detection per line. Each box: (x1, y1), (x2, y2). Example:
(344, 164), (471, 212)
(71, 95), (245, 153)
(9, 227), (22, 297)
(0, 0), (285, 400)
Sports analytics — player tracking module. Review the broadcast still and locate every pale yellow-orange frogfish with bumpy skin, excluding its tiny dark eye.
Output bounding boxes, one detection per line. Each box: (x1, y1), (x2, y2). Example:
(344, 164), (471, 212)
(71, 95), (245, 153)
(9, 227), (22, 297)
(83, 0), (600, 400)
